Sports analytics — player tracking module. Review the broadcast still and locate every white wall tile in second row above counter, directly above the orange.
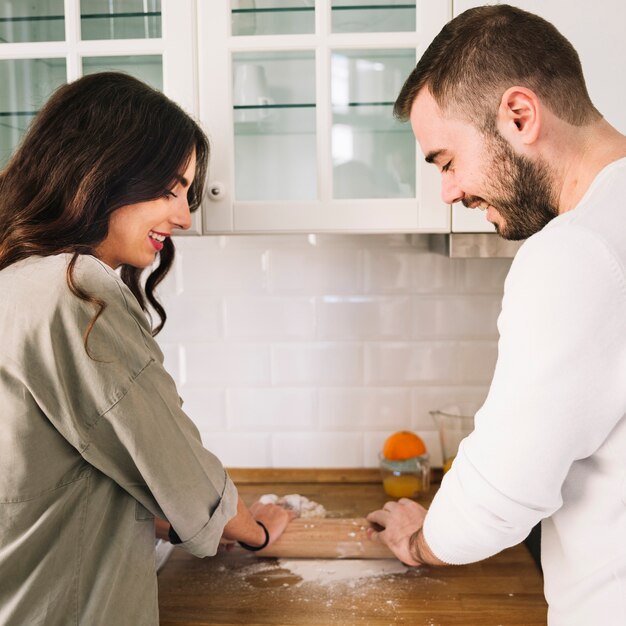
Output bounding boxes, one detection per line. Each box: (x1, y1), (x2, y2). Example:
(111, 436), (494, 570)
(318, 387), (411, 431)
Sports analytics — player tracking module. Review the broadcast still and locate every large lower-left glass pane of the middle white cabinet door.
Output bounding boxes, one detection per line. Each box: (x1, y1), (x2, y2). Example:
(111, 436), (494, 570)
(232, 51), (317, 200)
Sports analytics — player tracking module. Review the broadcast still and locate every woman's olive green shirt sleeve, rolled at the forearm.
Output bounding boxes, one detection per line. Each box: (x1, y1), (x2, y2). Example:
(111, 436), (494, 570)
(31, 257), (237, 556)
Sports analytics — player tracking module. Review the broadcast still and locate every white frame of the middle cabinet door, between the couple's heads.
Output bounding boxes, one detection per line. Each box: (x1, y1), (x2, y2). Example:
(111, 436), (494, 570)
(197, 0), (452, 233)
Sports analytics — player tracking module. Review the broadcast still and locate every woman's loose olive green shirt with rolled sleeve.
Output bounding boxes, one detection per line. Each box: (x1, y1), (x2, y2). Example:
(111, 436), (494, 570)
(0, 255), (237, 626)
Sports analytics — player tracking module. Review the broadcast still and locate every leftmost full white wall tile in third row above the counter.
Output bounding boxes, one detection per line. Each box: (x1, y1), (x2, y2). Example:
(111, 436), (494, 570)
(181, 342), (270, 386)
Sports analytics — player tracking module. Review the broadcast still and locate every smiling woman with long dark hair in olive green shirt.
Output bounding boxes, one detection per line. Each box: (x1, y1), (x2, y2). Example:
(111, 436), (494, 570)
(0, 73), (290, 626)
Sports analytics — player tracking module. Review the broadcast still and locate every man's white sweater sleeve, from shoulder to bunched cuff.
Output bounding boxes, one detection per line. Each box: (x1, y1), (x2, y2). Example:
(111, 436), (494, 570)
(424, 224), (626, 564)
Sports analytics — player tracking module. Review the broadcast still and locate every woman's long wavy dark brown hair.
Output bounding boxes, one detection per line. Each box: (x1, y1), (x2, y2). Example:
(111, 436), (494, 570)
(0, 72), (209, 347)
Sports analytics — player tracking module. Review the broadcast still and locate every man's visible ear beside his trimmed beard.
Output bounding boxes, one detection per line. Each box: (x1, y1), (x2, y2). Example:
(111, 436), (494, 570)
(497, 87), (542, 148)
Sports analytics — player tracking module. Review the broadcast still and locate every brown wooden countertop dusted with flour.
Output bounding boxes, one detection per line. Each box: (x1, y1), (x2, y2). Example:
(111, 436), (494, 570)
(158, 478), (547, 626)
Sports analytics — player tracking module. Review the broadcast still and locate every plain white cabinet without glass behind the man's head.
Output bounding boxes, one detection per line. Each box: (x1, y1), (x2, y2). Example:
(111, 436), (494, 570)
(452, 0), (626, 232)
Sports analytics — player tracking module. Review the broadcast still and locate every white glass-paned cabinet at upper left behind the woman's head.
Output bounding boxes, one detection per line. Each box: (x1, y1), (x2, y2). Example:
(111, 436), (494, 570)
(0, 0), (202, 234)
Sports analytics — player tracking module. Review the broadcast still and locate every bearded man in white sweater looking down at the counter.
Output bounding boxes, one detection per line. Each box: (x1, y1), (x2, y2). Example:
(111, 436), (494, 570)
(369, 5), (626, 626)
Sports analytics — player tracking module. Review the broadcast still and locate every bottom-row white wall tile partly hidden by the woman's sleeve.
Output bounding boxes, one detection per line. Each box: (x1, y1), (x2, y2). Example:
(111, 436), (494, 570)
(201, 432), (272, 468)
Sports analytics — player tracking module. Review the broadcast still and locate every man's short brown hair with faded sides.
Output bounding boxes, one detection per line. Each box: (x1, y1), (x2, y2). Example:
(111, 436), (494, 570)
(394, 4), (600, 128)
